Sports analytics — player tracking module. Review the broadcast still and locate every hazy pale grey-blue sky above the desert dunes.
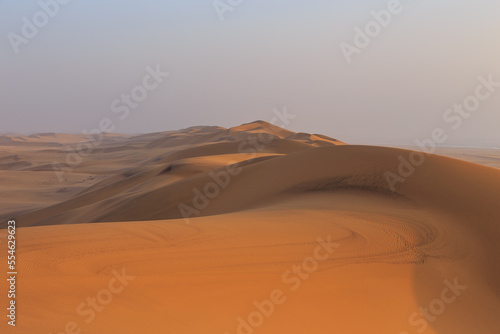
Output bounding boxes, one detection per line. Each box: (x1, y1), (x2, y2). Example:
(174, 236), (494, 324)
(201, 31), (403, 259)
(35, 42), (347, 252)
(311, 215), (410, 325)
(0, 0), (500, 146)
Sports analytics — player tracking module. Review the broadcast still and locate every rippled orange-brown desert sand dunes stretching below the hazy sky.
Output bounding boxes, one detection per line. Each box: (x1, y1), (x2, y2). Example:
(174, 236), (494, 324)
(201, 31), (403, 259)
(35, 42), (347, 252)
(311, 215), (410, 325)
(0, 122), (500, 334)
